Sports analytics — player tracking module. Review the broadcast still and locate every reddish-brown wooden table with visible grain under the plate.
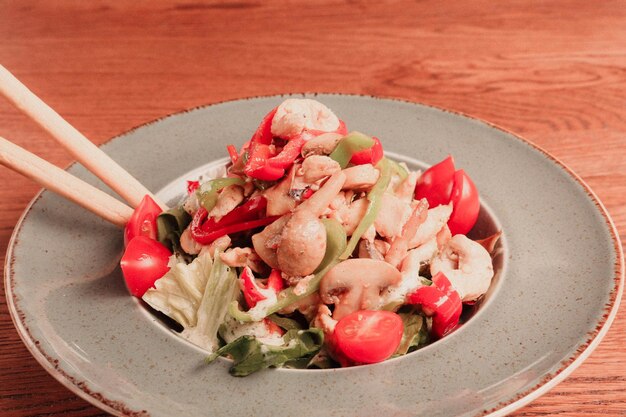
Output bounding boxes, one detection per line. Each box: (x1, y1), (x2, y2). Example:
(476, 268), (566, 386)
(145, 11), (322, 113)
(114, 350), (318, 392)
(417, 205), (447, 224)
(0, 0), (626, 416)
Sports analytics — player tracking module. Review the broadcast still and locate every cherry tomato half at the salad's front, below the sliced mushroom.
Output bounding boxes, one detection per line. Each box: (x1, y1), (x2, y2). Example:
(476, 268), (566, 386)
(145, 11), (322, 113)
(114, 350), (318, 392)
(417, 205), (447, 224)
(333, 310), (404, 363)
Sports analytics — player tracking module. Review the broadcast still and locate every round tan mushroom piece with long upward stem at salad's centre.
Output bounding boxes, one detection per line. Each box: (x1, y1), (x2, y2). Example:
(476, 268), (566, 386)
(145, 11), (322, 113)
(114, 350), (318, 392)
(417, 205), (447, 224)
(276, 171), (346, 276)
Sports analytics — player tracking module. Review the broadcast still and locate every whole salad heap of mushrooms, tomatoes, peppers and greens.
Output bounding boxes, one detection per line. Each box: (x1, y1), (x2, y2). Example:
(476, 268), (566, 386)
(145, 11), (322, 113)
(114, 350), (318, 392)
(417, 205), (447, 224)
(121, 99), (500, 376)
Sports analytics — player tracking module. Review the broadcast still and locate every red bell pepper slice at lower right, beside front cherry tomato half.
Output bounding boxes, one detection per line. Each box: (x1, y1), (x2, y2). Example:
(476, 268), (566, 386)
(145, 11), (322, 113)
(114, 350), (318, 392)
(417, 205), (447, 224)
(407, 272), (463, 338)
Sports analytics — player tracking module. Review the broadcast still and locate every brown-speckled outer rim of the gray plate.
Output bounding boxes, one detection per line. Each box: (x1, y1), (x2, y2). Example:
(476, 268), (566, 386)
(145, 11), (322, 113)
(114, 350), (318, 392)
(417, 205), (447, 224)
(4, 91), (625, 417)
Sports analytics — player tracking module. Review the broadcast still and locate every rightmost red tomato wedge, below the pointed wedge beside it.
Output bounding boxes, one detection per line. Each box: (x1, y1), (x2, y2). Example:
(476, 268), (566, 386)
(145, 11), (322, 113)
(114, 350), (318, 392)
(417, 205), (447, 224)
(448, 169), (480, 236)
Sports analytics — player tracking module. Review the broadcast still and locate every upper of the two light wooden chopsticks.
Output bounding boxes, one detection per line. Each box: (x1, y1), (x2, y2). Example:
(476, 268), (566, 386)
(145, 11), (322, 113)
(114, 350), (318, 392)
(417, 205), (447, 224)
(0, 65), (167, 210)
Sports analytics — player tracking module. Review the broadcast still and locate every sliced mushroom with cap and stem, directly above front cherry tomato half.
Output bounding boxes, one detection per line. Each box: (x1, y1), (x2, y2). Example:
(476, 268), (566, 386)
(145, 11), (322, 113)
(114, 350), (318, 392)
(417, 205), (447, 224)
(320, 258), (402, 320)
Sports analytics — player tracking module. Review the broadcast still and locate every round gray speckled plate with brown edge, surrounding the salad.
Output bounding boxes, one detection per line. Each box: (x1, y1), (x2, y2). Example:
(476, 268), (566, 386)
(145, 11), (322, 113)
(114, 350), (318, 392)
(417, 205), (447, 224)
(5, 95), (623, 417)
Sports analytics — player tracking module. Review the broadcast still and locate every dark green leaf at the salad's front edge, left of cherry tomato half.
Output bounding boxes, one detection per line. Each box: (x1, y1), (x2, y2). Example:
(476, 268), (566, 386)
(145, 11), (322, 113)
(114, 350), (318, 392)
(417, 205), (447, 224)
(206, 328), (324, 376)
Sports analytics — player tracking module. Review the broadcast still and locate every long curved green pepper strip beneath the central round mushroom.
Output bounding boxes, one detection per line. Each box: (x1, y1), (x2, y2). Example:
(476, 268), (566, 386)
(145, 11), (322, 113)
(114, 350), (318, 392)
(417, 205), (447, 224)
(228, 219), (346, 322)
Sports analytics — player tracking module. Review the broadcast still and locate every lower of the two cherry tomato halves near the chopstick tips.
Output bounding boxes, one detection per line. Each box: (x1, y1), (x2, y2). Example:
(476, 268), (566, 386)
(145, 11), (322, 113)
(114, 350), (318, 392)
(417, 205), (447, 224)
(120, 236), (172, 298)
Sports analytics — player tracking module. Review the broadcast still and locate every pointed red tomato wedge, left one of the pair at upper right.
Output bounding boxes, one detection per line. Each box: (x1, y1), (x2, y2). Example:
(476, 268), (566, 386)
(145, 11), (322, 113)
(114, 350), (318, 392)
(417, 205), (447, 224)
(415, 156), (454, 208)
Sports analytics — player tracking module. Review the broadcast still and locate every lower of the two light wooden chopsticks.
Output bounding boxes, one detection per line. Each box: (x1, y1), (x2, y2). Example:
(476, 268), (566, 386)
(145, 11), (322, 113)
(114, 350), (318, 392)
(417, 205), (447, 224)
(0, 136), (133, 227)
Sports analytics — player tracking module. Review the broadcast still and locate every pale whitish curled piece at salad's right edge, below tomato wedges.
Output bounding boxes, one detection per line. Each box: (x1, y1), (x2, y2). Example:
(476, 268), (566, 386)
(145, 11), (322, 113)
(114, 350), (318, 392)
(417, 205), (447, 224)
(430, 235), (493, 302)
